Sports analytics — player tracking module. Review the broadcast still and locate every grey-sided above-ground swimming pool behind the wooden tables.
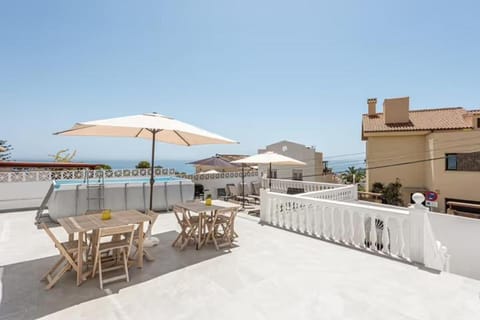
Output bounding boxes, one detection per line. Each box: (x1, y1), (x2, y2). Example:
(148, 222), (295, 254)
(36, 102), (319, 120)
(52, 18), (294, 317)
(48, 177), (194, 219)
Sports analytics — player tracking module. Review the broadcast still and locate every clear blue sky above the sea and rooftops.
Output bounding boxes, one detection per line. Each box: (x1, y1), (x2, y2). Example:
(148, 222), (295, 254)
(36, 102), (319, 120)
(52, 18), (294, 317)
(0, 0), (480, 159)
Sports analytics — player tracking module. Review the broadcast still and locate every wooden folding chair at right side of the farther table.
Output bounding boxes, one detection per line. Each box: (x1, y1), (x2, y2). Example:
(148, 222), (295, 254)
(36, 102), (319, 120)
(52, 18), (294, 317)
(205, 208), (237, 250)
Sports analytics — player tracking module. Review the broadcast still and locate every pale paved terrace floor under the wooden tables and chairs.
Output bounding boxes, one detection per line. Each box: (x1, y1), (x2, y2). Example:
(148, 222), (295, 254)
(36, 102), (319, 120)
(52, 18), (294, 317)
(0, 211), (480, 320)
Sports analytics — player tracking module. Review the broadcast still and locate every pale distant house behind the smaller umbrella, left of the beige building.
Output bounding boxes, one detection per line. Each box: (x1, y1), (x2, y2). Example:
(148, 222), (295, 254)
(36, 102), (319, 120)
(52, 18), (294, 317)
(258, 140), (331, 181)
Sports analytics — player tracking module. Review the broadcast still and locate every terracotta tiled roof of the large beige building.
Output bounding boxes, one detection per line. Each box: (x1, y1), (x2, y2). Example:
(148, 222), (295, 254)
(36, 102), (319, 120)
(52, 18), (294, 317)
(362, 107), (472, 133)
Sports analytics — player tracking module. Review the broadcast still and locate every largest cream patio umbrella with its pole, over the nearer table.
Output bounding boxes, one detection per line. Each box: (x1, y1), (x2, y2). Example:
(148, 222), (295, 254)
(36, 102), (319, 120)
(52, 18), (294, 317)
(54, 112), (237, 245)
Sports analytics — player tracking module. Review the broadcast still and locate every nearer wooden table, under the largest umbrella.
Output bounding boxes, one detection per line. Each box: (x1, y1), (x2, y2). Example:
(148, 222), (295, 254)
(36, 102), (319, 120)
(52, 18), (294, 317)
(58, 210), (149, 286)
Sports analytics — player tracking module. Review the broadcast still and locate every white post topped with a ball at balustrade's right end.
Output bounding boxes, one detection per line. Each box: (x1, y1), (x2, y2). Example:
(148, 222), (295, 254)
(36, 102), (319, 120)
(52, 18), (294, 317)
(408, 192), (428, 264)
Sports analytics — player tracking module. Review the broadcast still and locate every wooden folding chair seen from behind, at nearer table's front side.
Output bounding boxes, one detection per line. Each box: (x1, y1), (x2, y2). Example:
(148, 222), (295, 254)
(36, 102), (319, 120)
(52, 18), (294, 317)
(92, 225), (135, 289)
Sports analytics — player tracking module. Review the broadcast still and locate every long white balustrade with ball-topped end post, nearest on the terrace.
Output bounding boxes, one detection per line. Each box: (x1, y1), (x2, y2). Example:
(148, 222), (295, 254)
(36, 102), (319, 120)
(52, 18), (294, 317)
(260, 185), (448, 270)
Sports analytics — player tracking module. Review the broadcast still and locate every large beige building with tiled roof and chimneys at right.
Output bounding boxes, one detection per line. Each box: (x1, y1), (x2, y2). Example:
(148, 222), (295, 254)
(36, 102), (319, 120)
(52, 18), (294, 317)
(362, 97), (480, 213)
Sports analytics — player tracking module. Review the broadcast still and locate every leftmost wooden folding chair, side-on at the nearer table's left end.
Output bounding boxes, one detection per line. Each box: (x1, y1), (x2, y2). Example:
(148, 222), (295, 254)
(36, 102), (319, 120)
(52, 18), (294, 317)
(40, 223), (87, 290)
